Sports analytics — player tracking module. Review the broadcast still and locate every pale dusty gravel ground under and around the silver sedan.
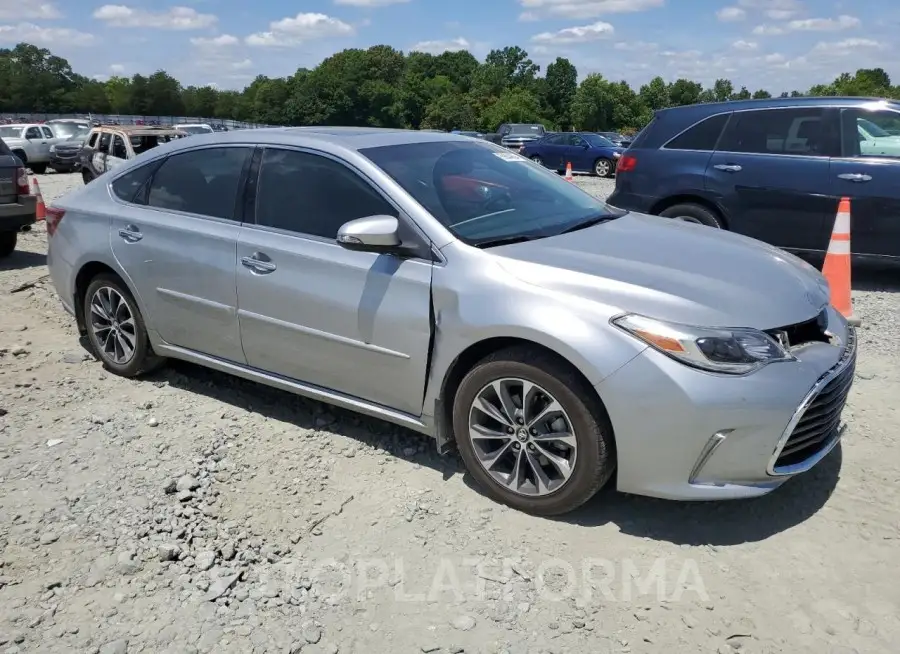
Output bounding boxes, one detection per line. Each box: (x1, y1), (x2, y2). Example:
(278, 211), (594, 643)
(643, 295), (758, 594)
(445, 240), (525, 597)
(0, 174), (900, 654)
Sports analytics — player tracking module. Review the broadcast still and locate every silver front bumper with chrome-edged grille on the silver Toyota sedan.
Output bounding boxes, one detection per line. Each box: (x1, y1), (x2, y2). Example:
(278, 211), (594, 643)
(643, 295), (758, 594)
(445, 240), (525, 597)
(597, 308), (856, 500)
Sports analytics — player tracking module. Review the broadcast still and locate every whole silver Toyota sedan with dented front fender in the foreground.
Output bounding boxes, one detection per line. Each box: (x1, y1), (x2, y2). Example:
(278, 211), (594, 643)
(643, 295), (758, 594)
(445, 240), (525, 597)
(47, 127), (856, 515)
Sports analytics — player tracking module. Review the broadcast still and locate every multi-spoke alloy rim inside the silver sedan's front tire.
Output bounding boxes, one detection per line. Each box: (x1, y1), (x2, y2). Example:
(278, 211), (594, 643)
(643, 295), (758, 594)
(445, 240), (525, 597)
(469, 378), (578, 496)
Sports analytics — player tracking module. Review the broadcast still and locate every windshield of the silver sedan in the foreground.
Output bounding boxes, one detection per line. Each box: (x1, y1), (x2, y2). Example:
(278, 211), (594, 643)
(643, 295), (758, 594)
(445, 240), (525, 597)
(360, 139), (625, 247)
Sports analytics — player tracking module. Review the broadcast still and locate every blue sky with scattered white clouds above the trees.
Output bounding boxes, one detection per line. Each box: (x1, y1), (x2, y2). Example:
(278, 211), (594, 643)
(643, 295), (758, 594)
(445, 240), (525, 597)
(0, 0), (900, 92)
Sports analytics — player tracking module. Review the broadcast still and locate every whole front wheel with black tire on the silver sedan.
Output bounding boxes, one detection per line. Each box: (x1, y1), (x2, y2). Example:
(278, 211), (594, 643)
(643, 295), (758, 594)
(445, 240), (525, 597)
(453, 347), (615, 516)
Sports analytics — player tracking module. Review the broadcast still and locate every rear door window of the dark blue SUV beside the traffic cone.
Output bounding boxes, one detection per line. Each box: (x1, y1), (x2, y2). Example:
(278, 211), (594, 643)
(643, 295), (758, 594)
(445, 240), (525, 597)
(718, 107), (839, 157)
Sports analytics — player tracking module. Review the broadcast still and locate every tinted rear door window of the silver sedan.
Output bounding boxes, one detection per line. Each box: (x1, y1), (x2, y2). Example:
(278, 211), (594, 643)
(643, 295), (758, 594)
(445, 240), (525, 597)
(147, 147), (251, 220)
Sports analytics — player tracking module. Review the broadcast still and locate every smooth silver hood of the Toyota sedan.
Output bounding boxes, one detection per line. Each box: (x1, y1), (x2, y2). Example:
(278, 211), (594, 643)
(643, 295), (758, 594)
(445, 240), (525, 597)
(491, 213), (829, 329)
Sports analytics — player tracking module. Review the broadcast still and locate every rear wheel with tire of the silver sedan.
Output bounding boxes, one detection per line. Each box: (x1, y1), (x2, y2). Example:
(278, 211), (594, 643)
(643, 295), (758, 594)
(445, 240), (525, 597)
(83, 274), (164, 377)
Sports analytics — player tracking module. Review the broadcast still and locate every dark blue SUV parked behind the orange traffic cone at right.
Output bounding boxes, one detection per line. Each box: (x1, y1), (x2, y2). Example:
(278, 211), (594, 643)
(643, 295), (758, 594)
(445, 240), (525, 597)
(609, 97), (900, 257)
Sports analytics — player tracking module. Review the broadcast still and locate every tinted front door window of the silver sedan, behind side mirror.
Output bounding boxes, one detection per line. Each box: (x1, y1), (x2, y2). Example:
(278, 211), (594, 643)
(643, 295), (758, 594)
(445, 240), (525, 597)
(256, 148), (397, 239)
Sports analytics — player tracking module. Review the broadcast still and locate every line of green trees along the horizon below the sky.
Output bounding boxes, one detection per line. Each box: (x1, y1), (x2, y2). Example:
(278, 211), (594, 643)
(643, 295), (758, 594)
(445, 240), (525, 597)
(0, 43), (900, 132)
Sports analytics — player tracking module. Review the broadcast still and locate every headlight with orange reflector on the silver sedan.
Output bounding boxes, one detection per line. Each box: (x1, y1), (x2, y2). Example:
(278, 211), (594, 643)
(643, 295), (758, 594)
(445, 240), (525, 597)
(613, 314), (795, 375)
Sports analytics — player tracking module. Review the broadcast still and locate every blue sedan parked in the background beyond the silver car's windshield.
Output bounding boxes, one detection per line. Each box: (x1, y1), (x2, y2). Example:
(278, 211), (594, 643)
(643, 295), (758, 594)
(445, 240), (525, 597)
(519, 132), (625, 177)
